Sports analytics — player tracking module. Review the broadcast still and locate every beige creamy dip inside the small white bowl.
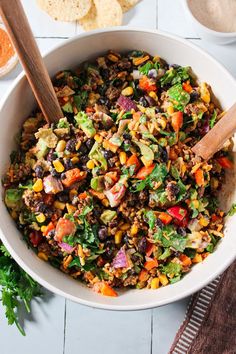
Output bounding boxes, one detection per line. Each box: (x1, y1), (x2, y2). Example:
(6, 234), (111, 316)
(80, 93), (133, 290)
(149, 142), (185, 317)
(188, 0), (236, 32)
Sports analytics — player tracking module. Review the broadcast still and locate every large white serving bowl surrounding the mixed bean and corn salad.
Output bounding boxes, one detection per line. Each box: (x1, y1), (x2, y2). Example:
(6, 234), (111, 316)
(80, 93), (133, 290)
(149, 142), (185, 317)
(0, 28), (236, 310)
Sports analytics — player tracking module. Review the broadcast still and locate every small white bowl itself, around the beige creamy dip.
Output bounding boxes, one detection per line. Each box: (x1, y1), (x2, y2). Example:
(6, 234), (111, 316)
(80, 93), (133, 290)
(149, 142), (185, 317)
(182, 0), (236, 44)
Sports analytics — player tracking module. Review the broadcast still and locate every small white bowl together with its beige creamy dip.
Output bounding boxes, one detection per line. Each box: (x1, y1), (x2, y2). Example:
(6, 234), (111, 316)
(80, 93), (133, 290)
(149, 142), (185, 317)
(183, 0), (236, 44)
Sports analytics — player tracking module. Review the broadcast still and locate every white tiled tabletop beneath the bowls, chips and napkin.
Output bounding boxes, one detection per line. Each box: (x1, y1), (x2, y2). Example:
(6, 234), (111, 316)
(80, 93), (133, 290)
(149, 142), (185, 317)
(0, 0), (236, 354)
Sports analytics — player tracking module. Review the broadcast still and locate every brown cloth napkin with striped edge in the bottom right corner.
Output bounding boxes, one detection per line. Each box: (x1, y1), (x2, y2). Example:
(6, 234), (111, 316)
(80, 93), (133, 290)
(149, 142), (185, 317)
(169, 261), (236, 354)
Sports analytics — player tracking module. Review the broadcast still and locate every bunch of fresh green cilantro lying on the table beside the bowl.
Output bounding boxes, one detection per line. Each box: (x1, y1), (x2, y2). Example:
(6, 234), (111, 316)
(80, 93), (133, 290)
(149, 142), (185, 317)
(0, 245), (41, 335)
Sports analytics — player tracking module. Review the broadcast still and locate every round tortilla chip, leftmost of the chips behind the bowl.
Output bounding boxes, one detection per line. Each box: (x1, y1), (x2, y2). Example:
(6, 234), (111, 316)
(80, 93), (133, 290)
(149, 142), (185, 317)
(37, 0), (92, 21)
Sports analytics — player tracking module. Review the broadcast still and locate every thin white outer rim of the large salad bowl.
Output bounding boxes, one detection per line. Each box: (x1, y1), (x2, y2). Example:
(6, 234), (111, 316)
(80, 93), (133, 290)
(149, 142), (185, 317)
(0, 26), (236, 311)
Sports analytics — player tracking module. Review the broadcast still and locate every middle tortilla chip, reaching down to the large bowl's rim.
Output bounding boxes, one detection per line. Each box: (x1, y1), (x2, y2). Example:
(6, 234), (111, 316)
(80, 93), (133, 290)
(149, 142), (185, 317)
(94, 0), (123, 28)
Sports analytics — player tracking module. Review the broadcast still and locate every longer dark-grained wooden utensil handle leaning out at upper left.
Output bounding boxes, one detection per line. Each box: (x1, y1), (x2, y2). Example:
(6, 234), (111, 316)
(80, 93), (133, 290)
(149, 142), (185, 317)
(0, 0), (63, 123)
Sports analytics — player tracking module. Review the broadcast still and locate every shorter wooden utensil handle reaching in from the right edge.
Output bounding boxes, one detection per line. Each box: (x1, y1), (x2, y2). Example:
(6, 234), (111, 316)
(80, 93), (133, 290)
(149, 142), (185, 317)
(192, 103), (236, 160)
